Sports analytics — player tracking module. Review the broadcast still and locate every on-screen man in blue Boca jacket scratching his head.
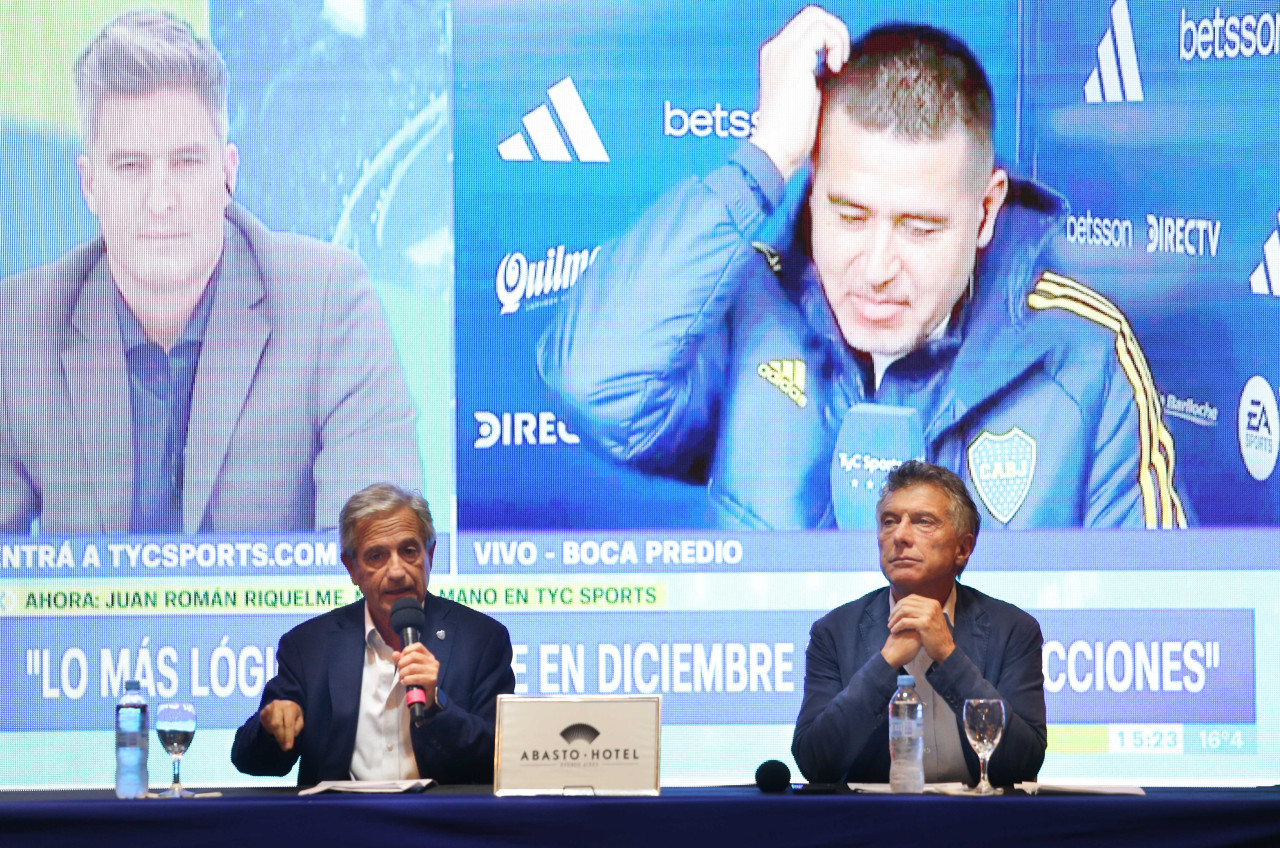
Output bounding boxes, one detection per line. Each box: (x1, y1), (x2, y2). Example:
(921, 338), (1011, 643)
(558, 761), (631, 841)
(539, 6), (1187, 528)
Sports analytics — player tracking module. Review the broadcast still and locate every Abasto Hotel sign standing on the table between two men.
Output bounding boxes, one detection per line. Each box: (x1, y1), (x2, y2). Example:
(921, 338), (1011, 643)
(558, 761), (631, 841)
(493, 694), (662, 795)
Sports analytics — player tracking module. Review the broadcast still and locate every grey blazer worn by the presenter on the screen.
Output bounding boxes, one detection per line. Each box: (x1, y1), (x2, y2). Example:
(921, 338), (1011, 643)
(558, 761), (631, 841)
(0, 204), (422, 533)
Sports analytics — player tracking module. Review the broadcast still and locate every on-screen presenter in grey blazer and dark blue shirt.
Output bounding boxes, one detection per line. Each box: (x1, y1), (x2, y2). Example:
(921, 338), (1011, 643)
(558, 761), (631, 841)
(0, 10), (422, 533)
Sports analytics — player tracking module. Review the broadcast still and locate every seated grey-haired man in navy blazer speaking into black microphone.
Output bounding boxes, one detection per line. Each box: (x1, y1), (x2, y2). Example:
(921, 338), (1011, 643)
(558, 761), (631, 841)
(232, 483), (515, 785)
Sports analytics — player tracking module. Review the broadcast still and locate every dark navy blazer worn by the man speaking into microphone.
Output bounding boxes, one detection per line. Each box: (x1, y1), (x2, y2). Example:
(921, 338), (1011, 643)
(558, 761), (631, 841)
(232, 593), (516, 785)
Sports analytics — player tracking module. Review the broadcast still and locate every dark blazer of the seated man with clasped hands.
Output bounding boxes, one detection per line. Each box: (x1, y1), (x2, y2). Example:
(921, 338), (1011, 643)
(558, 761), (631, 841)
(791, 584), (1048, 785)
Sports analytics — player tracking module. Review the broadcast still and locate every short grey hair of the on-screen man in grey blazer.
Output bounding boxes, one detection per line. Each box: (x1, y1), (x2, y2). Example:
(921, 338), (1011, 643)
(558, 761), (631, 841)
(76, 9), (230, 147)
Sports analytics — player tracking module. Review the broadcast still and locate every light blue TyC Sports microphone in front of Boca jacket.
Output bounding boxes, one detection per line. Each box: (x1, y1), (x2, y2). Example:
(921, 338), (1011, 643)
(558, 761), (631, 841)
(831, 404), (924, 530)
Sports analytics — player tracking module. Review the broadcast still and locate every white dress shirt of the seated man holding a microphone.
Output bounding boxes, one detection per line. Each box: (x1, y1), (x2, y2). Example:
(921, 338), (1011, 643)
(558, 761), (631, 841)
(351, 605), (419, 780)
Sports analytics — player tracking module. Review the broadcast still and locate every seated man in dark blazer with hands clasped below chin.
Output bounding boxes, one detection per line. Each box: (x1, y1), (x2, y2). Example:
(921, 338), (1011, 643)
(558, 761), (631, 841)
(791, 460), (1048, 785)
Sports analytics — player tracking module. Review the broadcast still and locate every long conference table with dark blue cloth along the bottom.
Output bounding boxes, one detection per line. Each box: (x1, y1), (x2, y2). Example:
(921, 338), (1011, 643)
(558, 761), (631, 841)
(0, 787), (1280, 848)
